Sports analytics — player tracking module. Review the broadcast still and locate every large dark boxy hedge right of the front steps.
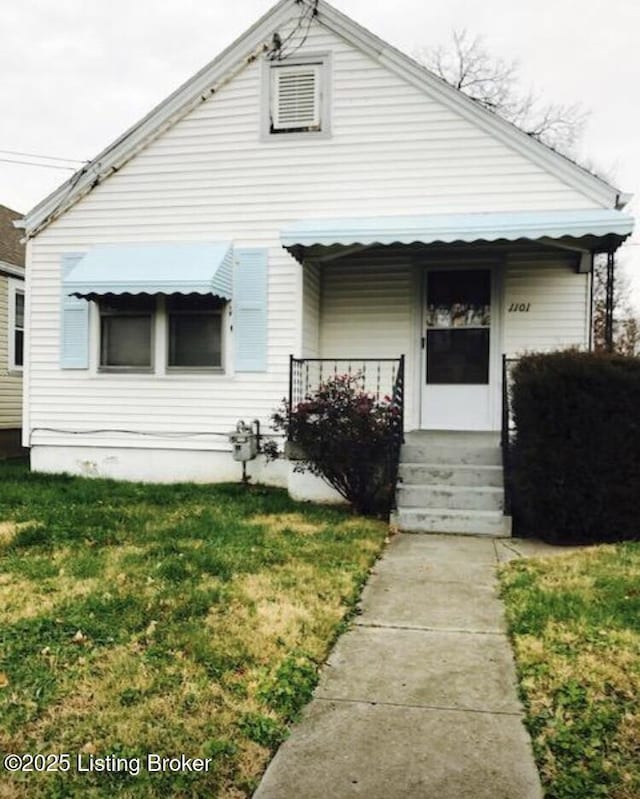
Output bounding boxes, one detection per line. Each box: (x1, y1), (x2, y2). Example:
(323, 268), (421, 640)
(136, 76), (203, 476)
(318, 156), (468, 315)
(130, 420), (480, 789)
(512, 351), (640, 543)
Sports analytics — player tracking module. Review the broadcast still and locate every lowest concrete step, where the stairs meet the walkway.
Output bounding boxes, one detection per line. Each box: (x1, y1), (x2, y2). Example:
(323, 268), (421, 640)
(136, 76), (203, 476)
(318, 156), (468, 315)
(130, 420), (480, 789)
(392, 508), (511, 538)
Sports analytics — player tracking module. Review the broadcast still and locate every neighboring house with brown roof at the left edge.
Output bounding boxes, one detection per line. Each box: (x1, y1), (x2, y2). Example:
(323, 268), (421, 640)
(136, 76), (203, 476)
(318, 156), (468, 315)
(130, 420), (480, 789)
(0, 205), (25, 457)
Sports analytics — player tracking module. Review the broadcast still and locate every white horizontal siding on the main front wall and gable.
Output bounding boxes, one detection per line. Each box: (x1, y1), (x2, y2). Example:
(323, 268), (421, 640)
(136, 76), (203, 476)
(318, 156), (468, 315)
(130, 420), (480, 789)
(29, 20), (594, 449)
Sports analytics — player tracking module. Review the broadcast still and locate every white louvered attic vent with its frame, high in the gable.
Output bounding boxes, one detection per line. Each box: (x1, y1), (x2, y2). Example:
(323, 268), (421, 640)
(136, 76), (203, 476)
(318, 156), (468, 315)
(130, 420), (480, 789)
(265, 56), (330, 137)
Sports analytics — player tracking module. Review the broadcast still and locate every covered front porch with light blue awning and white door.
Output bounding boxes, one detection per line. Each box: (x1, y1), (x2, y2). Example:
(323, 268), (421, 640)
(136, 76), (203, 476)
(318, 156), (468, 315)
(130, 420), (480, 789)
(281, 209), (631, 432)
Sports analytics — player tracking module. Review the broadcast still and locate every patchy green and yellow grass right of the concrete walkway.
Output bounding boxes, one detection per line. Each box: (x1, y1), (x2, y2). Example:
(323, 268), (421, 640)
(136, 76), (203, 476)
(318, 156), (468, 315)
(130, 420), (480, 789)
(501, 543), (640, 799)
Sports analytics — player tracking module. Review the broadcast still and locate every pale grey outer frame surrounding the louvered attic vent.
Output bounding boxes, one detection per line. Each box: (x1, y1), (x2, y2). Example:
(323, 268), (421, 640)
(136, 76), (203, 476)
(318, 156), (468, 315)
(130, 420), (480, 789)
(261, 53), (333, 143)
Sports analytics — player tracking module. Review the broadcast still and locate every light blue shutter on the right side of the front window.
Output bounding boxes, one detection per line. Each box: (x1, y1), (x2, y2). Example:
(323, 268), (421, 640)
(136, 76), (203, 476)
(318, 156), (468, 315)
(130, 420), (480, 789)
(232, 248), (268, 372)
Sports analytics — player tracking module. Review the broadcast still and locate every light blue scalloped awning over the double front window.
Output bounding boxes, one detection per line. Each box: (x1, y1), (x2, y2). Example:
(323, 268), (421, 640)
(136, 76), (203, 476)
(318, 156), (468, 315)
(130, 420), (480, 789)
(64, 241), (233, 300)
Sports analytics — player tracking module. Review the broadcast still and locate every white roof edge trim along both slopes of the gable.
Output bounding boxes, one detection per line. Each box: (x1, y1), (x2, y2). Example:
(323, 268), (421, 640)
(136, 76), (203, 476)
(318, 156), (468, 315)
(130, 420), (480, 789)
(21, 0), (630, 236)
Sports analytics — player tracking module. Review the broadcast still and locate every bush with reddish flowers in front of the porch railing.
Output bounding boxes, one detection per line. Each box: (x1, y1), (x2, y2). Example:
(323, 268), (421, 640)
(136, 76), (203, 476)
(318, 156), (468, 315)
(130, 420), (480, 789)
(273, 374), (401, 517)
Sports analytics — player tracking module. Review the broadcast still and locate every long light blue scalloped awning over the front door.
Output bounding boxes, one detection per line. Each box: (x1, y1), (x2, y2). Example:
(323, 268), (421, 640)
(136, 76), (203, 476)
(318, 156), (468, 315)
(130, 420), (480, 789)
(280, 208), (633, 254)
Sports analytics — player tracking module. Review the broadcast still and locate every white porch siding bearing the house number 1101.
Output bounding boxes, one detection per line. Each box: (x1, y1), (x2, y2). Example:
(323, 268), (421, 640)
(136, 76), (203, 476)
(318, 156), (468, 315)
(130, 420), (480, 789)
(503, 253), (590, 356)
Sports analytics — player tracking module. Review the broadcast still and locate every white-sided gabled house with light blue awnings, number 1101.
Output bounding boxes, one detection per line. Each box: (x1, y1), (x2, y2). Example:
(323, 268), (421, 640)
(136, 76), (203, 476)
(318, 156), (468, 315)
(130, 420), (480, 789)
(17, 0), (632, 529)
